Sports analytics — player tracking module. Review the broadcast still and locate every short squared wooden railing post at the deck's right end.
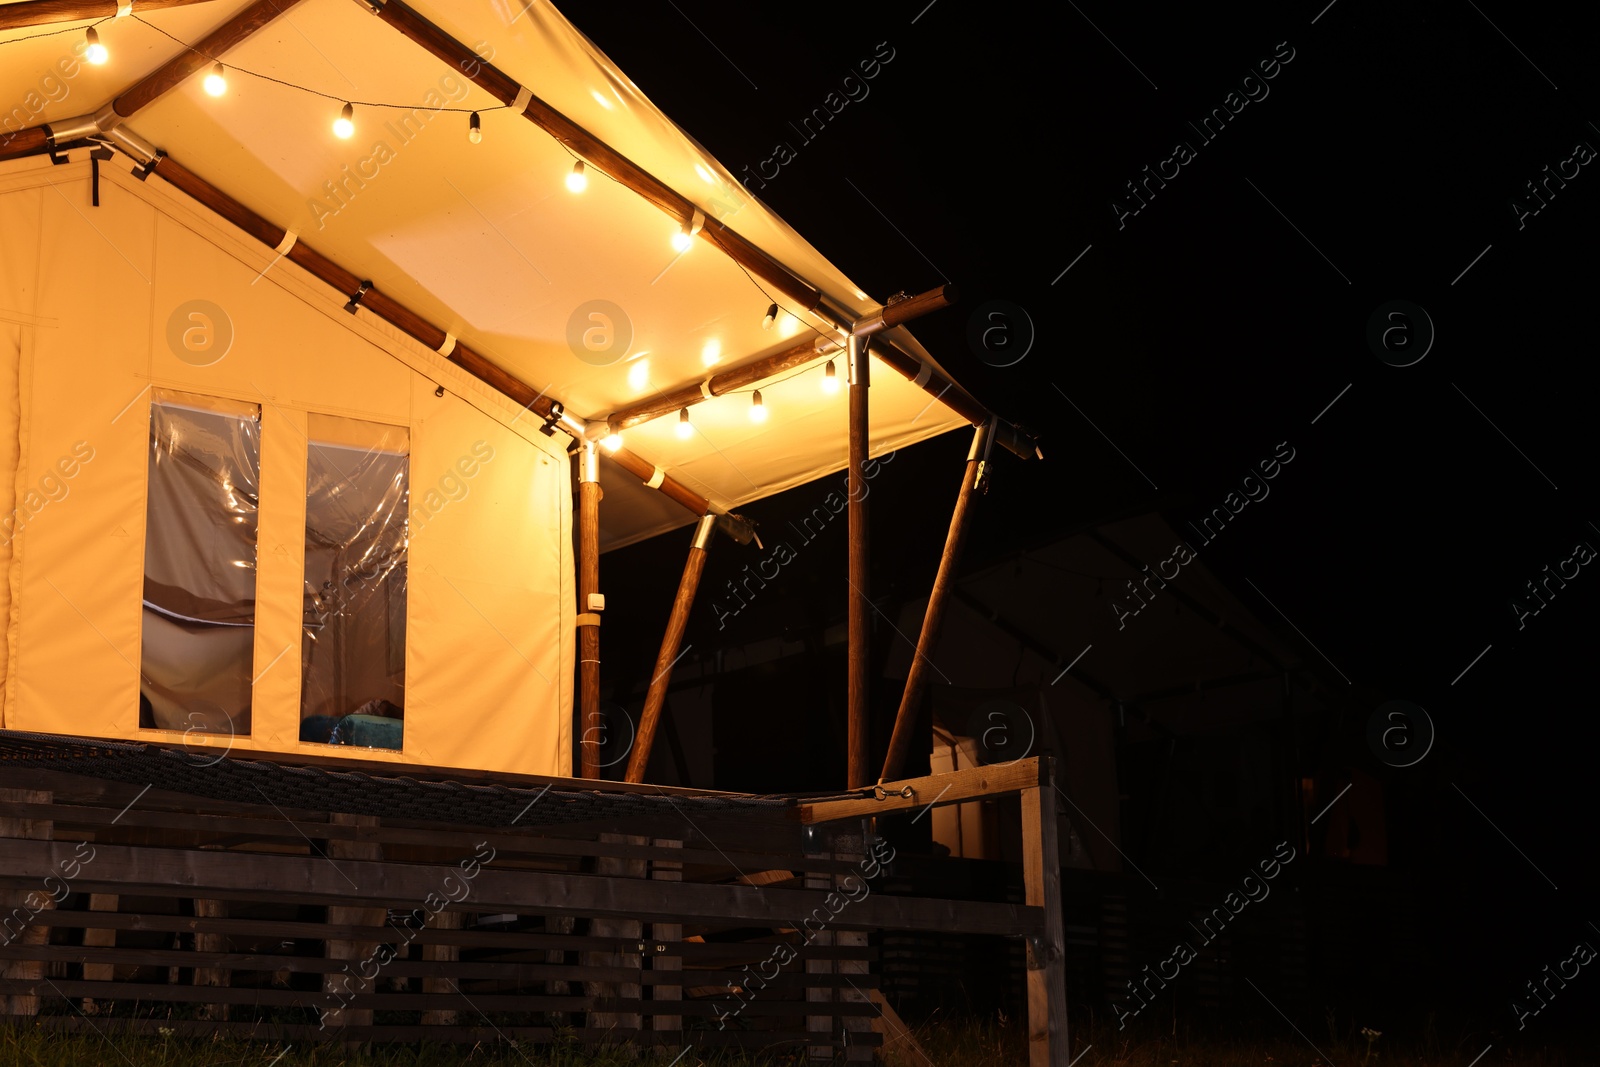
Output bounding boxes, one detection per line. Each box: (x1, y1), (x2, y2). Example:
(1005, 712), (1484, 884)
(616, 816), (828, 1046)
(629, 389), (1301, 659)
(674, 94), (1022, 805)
(1022, 757), (1069, 1067)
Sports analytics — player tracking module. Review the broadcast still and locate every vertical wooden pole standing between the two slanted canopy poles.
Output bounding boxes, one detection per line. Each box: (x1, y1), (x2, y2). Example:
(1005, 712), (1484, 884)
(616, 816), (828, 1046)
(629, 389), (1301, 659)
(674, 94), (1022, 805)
(845, 334), (872, 789)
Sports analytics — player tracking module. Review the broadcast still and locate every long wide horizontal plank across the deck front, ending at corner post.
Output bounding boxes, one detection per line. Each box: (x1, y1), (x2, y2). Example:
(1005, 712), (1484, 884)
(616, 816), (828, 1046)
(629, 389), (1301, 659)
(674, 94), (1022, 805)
(0, 838), (1043, 934)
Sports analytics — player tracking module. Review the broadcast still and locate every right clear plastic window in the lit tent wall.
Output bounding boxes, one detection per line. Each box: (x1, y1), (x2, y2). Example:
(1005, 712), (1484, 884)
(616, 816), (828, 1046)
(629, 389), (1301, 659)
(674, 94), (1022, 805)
(301, 414), (410, 749)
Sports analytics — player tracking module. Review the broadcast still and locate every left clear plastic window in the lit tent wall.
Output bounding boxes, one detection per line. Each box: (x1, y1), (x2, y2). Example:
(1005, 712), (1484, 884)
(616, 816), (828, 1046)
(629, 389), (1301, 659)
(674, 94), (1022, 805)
(139, 390), (261, 736)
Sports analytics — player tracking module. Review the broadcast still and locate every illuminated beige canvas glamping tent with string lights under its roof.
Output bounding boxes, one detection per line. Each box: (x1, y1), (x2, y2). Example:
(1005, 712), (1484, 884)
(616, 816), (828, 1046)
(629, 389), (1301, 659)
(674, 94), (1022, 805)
(0, 0), (1035, 784)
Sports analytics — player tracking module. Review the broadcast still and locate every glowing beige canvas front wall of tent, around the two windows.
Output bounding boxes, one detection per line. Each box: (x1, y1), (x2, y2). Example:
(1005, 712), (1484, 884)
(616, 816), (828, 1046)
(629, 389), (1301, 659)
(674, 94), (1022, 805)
(0, 160), (573, 774)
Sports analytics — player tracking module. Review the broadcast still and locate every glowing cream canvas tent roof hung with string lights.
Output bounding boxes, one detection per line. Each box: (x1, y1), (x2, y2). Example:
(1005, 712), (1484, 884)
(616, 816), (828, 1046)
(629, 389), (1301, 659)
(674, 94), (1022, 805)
(0, 0), (966, 547)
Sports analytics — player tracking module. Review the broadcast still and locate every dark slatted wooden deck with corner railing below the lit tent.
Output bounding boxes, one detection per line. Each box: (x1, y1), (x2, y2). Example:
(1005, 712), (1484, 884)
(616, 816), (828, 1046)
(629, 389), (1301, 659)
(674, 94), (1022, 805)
(0, 739), (1067, 1067)
